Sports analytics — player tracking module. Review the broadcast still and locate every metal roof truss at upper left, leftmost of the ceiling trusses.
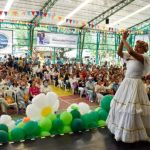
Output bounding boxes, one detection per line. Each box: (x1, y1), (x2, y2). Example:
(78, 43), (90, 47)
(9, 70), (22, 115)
(30, 0), (58, 23)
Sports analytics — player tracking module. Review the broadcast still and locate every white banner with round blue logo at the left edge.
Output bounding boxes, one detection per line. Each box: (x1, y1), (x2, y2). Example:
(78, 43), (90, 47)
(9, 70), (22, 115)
(0, 30), (13, 54)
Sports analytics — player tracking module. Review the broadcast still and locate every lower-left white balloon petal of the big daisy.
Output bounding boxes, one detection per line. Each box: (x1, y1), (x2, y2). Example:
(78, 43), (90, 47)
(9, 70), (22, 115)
(26, 104), (41, 121)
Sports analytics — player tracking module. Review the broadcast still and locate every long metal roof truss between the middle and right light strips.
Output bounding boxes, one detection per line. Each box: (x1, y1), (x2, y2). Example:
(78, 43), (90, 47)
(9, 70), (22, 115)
(81, 0), (135, 28)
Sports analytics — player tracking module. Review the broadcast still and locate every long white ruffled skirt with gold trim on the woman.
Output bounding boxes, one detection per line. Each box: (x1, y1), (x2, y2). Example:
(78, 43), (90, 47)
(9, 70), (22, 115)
(107, 78), (150, 143)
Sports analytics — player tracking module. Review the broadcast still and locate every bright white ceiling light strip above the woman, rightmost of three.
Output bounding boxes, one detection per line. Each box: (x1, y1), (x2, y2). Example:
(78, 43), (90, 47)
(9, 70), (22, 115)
(109, 4), (150, 27)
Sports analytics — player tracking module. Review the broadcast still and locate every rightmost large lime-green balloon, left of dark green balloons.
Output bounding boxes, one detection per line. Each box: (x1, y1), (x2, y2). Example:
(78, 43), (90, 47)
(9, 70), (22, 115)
(60, 111), (72, 125)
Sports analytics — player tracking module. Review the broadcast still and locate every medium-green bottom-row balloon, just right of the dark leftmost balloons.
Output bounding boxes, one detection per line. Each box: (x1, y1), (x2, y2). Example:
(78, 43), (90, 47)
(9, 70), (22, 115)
(11, 128), (25, 141)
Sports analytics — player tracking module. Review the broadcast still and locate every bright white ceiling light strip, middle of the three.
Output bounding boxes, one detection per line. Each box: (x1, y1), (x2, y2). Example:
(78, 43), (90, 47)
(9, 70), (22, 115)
(57, 0), (92, 26)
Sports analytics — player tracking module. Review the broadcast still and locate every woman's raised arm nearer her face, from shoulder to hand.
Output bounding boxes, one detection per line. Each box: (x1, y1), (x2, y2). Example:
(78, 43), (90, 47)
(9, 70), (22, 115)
(122, 31), (144, 64)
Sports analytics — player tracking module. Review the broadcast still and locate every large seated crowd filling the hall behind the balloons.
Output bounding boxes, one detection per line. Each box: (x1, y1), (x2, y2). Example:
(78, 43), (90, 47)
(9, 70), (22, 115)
(0, 55), (150, 113)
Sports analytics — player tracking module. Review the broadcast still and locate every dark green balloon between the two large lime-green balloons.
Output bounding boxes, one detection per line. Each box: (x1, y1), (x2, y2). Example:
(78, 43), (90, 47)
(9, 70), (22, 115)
(51, 118), (64, 134)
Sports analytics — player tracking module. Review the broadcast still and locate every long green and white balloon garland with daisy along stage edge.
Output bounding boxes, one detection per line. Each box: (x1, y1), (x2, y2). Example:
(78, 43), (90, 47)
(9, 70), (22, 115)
(0, 93), (112, 143)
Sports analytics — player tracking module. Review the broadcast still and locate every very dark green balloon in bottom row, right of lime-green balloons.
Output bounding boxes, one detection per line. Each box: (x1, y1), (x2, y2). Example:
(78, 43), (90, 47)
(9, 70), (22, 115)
(71, 119), (84, 132)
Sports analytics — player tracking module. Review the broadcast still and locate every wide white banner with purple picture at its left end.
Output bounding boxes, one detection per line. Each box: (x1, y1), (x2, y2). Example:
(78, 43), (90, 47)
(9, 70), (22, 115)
(37, 32), (78, 48)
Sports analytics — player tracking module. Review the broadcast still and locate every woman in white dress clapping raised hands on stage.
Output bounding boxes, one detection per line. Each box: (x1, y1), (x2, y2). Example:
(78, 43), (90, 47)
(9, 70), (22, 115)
(107, 31), (150, 143)
